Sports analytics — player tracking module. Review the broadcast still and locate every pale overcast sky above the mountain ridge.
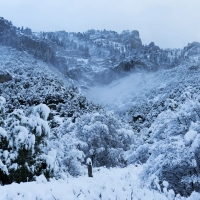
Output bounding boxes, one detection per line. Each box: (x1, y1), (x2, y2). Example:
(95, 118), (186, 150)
(0, 0), (200, 48)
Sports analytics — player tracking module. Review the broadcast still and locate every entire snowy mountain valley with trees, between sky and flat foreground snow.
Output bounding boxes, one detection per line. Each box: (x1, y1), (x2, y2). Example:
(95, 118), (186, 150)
(0, 18), (200, 199)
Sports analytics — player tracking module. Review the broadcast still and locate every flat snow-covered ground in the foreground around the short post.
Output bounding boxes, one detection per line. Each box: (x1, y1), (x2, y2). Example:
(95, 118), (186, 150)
(0, 165), (200, 200)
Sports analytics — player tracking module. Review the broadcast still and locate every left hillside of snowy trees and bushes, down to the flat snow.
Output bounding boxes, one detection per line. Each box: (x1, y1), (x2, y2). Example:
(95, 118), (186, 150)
(0, 46), (133, 184)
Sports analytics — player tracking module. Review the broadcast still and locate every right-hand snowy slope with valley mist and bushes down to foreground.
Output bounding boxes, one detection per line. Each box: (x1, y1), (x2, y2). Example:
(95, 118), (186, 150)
(87, 63), (200, 196)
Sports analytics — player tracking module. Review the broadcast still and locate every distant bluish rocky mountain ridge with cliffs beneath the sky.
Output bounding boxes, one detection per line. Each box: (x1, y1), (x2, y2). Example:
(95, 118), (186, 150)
(0, 18), (200, 87)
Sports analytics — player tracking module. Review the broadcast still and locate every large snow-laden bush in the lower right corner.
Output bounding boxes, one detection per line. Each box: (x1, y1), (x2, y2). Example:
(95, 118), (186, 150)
(127, 97), (200, 196)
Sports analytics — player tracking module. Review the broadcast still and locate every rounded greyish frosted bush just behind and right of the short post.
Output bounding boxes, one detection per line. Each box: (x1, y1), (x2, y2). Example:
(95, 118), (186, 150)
(76, 110), (133, 167)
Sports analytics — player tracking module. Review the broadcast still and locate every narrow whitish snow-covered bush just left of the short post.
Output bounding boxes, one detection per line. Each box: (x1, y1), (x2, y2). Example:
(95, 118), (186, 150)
(51, 119), (86, 177)
